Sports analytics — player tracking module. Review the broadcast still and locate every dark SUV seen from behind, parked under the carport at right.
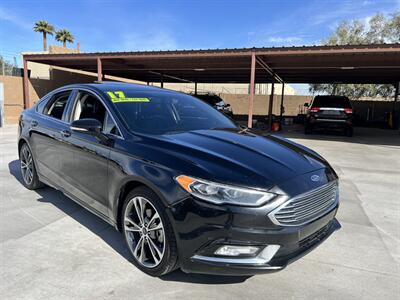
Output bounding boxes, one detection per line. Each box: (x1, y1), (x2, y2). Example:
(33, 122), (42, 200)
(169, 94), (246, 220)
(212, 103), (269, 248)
(304, 96), (353, 136)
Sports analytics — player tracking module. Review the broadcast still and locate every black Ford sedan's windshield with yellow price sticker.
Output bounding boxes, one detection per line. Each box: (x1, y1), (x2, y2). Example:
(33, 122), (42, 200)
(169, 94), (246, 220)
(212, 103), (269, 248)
(107, 89), (237, 135)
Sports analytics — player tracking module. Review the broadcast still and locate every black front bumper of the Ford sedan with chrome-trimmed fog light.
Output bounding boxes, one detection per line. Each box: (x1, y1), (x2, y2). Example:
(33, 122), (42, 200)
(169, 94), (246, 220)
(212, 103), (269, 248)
(168, 197), (340, 275)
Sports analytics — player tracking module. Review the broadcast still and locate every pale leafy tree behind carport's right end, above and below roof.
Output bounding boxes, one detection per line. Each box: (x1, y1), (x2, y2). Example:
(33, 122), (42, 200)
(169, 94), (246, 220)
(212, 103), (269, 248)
(309, 12), (400, 99)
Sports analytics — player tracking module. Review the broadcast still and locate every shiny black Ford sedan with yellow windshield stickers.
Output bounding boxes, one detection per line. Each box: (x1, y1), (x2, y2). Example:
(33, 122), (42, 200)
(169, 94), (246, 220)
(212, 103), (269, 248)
(18, 83), (340, 276)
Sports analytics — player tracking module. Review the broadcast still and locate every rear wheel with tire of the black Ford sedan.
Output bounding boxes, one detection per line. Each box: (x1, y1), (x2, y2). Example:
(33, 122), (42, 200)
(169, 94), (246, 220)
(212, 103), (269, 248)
(19, 143), (44, 190)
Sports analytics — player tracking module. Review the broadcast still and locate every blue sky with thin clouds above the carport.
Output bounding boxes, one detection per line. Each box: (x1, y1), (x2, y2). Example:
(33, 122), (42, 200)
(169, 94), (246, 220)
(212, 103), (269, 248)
(0, 0), (400, 93)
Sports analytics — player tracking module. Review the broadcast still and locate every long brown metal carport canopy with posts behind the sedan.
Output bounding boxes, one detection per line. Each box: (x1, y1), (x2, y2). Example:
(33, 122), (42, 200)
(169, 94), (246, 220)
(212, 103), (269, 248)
(23, 44), (400, 126)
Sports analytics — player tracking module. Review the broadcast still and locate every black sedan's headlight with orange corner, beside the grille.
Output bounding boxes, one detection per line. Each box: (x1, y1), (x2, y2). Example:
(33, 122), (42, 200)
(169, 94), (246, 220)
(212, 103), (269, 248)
(175, 175), (276, 206)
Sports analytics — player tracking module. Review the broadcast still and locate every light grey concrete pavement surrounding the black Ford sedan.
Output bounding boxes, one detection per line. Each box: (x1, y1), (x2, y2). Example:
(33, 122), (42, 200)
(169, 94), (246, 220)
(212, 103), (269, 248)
(0, 126), (400, 299)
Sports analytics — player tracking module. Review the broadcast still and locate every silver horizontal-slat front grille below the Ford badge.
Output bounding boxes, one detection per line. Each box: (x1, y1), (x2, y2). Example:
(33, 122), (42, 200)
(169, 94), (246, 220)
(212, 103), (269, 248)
(269, 181), (338, 226)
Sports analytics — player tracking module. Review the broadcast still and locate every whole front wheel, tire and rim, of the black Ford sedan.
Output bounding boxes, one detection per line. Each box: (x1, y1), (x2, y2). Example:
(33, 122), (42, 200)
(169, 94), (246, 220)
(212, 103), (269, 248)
(121, 187), (178, 276)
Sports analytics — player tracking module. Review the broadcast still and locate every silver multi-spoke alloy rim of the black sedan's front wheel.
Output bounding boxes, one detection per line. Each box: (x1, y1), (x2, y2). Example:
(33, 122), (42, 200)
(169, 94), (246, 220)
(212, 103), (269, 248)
(124, 196), (165, 268)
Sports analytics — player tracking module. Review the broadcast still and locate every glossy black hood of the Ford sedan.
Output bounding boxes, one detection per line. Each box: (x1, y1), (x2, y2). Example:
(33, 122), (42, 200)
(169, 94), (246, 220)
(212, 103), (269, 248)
(145, 129), (329, 188)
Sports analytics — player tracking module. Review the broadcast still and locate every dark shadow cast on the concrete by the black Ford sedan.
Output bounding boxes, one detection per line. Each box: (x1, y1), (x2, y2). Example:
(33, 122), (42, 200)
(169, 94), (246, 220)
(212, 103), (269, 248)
(8, 160), (249, 284)
